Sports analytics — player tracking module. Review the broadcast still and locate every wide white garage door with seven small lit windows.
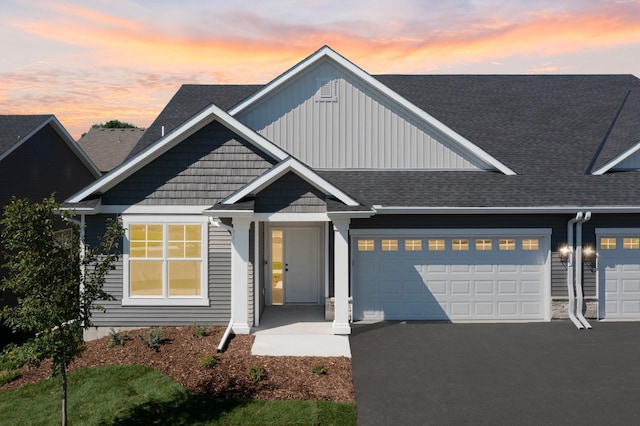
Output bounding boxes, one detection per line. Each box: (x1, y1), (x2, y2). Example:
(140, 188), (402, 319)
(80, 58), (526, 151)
(352, 230), (550, 320)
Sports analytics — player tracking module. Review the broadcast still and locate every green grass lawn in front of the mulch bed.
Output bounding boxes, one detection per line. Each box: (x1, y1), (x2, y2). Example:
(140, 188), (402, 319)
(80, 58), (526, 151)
(0, 366), (356, 425)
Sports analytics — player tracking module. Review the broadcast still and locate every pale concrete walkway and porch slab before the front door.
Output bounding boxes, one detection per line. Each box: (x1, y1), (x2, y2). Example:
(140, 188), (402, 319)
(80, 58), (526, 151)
(251, 306), (351, 358)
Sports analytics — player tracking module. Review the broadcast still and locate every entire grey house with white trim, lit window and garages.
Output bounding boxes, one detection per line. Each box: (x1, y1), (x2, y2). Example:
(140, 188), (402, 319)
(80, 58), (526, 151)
(63, 47), (640, 334)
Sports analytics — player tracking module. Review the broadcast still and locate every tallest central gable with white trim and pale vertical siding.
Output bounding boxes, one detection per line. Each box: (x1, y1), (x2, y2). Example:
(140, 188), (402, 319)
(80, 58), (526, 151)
(229, 46), (515, 174)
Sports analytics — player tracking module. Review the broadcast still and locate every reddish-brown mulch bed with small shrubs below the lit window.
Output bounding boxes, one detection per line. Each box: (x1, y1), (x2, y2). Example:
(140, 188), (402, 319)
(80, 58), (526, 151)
(0, 327), (354, 402)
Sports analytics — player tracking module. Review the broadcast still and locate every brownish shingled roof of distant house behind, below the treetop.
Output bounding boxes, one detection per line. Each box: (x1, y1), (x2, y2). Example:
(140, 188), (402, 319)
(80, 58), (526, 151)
(78, 127), (144, 173)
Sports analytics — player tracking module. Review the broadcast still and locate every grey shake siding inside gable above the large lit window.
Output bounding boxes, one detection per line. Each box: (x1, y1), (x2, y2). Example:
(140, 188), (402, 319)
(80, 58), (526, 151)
(102, 122), (274, 206)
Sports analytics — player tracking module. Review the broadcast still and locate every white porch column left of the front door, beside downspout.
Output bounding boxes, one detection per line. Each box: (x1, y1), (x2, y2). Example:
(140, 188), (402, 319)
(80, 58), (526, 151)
(231, 217), (251, 334)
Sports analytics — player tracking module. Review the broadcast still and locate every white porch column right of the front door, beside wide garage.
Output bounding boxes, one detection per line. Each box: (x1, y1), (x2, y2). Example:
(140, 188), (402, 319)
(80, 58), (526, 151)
(332, 218), (351, 334)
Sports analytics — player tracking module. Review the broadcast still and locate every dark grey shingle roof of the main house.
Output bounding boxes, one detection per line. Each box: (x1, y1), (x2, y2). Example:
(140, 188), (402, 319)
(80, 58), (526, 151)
(111, 75), (640, 211)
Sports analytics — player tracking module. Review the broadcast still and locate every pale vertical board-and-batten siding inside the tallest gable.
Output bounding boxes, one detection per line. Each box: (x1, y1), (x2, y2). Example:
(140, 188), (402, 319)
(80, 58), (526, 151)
(237, 60), (490, 170)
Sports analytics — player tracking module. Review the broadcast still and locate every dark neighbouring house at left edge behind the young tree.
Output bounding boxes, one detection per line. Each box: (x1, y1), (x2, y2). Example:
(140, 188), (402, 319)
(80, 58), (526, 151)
(0, 115), (100, 342)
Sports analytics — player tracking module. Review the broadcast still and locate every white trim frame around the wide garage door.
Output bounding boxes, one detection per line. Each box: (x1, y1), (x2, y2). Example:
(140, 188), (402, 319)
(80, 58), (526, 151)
(351, 228), (551, 322)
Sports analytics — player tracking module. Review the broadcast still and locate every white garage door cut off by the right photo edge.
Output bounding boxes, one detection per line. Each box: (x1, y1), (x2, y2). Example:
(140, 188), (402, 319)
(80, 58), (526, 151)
(597, 229), (640, 320)
